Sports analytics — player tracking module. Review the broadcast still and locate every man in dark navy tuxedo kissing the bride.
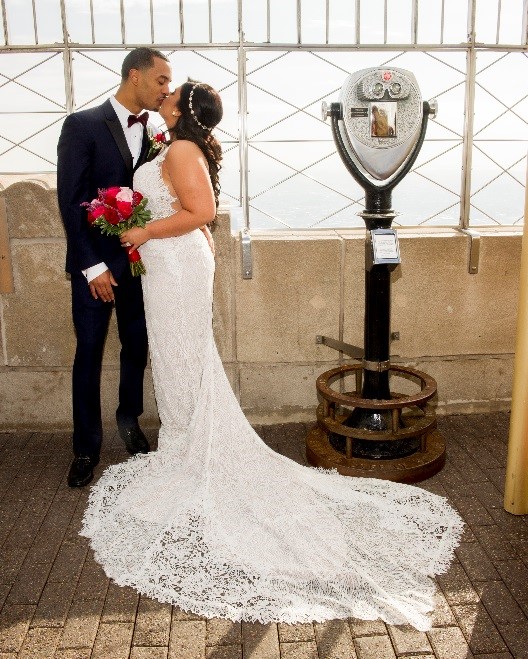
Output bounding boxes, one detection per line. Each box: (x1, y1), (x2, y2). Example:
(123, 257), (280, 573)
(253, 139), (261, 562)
(57, 48), (171, 487)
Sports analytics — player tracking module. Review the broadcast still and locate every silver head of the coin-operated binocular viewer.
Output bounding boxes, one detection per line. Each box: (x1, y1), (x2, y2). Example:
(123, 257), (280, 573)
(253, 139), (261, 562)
(322, 67), (436, 187)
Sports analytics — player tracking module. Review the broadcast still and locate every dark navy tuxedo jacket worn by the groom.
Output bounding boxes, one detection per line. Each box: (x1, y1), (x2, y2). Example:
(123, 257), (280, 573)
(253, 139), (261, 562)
(57, 100), (149, 277)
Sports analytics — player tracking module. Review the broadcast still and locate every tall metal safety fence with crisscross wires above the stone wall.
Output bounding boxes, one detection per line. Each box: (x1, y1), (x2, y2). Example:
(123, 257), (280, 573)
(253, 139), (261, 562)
(0, 0), (528, 229)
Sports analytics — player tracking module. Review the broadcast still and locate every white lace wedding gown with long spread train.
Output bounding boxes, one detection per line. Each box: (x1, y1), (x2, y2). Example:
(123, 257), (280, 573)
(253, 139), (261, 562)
(81, 151), (462, 630)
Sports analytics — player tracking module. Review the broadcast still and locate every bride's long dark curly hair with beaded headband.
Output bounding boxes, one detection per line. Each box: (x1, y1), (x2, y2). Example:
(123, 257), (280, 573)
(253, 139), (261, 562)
(169, 79), (223, 208)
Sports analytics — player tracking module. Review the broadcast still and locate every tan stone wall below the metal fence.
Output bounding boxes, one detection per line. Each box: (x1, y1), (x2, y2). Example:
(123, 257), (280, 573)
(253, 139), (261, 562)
(0, 180), (521, 430)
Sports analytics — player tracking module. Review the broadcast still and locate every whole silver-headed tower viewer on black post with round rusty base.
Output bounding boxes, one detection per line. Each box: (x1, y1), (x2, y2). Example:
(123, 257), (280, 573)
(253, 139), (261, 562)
(306, 68), (445, 482)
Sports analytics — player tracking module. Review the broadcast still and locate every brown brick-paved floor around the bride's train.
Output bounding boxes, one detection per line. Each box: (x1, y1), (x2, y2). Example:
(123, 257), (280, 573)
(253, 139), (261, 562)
(0, 413), (528, 659)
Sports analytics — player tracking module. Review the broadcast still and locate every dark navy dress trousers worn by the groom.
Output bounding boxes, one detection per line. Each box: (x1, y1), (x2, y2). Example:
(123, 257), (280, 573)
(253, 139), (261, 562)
(71, 267), (148, 457)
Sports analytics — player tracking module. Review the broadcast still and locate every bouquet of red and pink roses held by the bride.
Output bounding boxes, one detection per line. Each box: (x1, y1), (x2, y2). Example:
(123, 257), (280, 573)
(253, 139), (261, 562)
(81, 187), (150, 277)
